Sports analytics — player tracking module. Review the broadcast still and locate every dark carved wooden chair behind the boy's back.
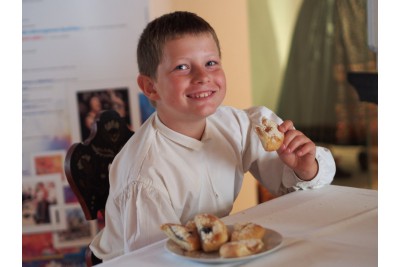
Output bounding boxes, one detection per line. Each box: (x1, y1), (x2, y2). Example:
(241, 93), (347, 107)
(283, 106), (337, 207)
(64, 110), (134, 266)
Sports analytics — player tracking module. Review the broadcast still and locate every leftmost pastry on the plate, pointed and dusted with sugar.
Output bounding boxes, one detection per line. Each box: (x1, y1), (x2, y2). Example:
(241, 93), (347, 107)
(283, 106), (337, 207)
(160, 221), (201, 251)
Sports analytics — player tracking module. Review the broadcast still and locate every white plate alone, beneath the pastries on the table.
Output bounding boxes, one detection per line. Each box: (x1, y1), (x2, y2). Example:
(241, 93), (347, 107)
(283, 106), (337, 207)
(165, 226), (282, 263)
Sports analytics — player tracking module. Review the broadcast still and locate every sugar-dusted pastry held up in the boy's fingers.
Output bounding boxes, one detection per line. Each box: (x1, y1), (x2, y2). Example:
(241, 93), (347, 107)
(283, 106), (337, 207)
(255, 117), (284, 151)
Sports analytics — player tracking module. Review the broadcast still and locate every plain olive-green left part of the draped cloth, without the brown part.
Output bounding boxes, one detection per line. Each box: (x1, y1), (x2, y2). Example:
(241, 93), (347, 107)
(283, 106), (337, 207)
(278, 0), (336, 141)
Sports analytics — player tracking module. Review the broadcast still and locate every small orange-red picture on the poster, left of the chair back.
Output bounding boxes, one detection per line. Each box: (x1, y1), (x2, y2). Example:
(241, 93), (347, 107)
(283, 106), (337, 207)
(31, 150), (68, 185)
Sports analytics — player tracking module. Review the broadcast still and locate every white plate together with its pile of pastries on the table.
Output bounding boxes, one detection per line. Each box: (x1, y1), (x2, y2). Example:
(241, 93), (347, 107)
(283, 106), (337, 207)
(160, 213), (282, 263)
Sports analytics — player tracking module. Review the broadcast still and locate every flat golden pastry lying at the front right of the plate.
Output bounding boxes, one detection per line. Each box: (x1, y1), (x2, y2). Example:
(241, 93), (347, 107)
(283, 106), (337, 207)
(219, 239), (264, 258)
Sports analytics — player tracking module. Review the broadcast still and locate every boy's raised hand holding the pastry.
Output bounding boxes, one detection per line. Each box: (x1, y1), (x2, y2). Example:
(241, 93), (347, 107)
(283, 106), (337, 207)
(277, 120), (318, 180)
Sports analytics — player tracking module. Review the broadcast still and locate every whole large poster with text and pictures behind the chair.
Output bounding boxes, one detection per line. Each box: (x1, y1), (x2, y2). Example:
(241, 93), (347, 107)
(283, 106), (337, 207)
(22, 0), (154, 266)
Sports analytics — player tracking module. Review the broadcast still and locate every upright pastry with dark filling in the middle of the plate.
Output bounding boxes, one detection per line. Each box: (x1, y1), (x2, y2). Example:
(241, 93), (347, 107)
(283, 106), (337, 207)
(194, 214), (229, 252)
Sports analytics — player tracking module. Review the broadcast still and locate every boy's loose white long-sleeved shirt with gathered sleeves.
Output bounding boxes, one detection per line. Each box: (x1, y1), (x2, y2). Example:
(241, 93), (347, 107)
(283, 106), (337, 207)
(90, 106), (335, 260)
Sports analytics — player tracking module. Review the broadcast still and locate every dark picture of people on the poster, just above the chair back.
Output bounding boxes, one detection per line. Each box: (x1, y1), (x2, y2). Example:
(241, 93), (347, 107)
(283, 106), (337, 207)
(77, 87), (132, 141)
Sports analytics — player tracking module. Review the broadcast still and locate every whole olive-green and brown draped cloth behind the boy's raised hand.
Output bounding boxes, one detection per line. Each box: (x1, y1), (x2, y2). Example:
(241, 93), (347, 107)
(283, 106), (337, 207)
(277, 0), (376, 144)
